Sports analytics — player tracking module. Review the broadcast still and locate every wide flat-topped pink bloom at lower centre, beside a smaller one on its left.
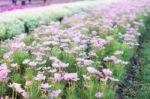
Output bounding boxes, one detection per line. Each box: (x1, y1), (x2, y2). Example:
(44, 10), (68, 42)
(64, 73), (79, 81)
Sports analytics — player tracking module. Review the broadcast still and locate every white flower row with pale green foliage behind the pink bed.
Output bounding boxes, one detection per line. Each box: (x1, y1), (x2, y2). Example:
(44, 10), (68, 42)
(0, 0), (116, 40)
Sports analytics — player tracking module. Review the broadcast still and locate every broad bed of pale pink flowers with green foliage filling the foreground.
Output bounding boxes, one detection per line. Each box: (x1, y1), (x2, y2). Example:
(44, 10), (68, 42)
(0, 0), (150, 99)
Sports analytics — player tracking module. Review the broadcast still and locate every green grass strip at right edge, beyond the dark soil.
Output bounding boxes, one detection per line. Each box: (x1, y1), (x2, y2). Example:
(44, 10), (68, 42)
(137, 16), (150, 99)
